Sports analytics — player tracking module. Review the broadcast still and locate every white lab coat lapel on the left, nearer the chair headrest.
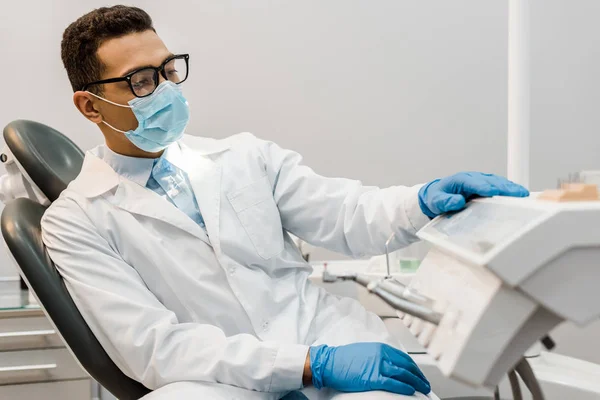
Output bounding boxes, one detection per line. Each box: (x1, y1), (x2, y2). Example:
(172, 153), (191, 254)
(112, 178), (210, 244)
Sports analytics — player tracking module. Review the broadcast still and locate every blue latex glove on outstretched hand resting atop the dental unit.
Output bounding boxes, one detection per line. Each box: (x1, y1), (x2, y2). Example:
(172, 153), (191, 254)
(419, 172), (529, 218)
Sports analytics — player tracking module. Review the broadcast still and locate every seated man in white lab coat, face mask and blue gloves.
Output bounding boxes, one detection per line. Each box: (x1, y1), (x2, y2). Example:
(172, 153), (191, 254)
(42, 6), (528, 399)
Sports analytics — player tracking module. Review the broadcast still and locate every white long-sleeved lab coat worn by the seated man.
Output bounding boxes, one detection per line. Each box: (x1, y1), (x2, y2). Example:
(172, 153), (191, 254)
(42, 133), (428, 397)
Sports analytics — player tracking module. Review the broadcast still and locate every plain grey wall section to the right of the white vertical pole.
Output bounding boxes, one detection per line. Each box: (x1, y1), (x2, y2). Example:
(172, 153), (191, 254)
(531, 0), (600, 189)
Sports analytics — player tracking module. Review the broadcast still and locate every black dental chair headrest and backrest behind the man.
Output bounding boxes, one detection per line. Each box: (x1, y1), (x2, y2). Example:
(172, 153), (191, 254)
(0, 120), (150, 400)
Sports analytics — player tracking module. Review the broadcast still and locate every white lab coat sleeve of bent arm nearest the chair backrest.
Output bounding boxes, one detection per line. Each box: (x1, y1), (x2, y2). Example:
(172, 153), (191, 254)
(42, 198), (308, 392)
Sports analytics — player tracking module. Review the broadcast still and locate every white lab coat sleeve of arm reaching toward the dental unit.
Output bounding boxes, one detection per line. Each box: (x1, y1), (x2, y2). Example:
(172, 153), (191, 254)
(255, 139), (429, 258)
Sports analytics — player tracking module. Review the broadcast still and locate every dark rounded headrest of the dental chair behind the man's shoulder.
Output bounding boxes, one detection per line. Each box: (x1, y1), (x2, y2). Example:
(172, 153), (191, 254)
(4, 120), (83, 201)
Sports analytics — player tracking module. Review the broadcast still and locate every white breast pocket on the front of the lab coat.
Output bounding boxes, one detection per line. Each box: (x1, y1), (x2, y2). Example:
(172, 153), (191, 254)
(227, 176), (283, 260)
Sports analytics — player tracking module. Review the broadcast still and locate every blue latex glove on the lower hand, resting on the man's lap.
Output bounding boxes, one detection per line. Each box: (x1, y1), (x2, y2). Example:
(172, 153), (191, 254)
(309, 343), (431, 395)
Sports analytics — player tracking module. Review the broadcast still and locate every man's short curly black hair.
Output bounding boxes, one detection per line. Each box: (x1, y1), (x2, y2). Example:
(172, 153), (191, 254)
(60, 5), (154, 94)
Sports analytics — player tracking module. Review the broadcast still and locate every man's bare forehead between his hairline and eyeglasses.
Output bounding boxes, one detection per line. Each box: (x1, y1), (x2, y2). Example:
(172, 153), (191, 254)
(98, 30), (171, 79)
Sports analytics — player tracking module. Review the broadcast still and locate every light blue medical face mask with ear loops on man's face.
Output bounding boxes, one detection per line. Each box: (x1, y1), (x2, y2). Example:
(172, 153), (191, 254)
(87, 81), (190, 153)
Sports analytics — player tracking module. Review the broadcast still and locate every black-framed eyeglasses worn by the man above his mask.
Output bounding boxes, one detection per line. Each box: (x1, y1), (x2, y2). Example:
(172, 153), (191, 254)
(81, 54), (190, 97)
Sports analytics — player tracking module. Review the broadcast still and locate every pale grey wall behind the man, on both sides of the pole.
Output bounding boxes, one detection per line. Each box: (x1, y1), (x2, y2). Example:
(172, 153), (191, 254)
(0, 0), (600, 361)
